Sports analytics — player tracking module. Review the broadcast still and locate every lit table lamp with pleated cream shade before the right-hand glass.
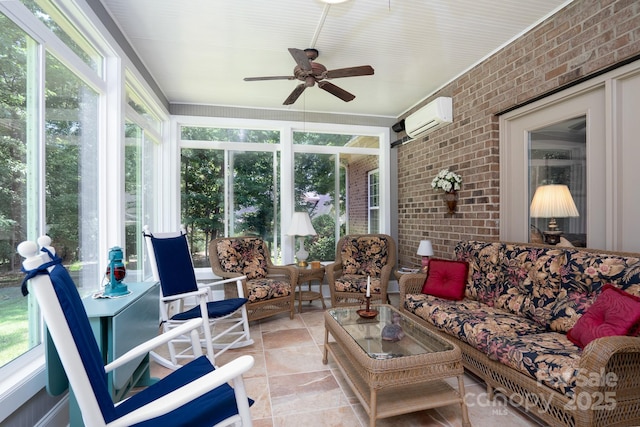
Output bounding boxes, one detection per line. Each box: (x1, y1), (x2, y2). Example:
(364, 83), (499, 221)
(529, 184), (580, 245)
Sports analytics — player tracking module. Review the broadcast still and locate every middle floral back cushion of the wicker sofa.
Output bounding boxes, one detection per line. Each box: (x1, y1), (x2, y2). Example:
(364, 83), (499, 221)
(495, 244), (567, 327)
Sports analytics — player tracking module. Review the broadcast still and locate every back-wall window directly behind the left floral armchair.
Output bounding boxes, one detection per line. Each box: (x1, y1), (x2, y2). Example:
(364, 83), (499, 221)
(181, 127), (280, 267)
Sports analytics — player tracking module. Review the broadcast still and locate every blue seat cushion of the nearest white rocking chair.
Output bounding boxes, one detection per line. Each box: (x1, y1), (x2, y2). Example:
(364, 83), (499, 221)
(116, 356), (254, 427)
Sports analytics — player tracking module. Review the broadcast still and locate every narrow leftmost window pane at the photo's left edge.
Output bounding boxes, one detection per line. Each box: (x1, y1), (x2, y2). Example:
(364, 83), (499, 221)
(0, 13), (40, 366)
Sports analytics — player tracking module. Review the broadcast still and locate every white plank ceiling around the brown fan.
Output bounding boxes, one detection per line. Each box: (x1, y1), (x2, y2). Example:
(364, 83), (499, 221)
(101, 0), (570, 117)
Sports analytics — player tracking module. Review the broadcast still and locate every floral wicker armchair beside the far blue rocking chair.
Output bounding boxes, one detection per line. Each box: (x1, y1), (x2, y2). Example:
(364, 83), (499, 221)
(209, 237), (298, 321)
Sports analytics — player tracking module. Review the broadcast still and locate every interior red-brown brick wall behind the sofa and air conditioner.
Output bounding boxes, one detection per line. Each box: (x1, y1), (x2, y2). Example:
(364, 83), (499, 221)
(397, 0), (640, 266)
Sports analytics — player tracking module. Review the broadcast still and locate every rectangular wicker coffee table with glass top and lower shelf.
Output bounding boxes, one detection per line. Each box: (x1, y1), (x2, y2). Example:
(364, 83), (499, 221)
(322, 305), (471, 427)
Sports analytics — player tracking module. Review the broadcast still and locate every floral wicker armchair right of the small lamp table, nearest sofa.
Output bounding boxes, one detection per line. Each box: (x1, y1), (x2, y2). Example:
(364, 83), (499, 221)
(325, 234), (396, 307)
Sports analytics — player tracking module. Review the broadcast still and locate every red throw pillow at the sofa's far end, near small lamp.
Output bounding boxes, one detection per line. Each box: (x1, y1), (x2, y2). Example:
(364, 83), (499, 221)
(422, 258), (469, 301)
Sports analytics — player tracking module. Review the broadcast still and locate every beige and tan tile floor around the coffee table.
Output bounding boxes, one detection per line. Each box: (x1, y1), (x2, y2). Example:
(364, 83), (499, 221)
(151, 295), (544, 427)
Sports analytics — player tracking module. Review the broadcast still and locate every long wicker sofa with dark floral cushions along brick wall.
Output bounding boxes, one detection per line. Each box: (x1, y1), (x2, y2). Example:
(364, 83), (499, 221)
(400, 241), (640, 427)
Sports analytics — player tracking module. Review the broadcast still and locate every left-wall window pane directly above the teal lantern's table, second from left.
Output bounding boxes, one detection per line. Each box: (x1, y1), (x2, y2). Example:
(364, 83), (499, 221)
(43, 54), (100, 294)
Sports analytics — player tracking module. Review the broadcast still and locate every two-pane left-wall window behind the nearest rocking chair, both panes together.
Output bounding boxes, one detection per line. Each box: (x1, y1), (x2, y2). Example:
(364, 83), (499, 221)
(0, 5), (99, 372)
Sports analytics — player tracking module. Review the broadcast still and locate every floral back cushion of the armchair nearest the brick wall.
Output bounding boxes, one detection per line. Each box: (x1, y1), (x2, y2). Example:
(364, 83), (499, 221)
(340, 236), (389, 278)
